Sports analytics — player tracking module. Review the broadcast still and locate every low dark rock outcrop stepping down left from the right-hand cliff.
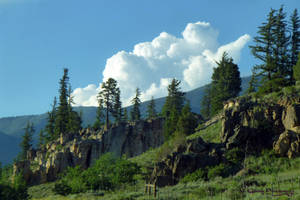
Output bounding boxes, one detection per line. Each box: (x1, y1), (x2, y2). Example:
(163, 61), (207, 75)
(150, 137), (221, 187)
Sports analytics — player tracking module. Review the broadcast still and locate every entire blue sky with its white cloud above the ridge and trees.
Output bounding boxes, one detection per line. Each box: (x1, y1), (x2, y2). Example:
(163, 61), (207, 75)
(0, 0), (300, 117)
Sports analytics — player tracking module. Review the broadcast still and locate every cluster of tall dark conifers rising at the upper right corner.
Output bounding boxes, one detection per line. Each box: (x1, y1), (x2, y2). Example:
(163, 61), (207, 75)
(249, 6), (300, 94)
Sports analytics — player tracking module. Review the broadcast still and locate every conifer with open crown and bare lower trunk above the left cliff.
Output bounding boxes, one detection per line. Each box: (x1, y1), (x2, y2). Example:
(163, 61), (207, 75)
(98, 78), (119, 129)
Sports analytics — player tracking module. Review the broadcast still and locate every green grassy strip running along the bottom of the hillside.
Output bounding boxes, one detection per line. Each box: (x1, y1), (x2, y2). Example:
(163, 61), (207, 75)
(29, 156), (300, 200)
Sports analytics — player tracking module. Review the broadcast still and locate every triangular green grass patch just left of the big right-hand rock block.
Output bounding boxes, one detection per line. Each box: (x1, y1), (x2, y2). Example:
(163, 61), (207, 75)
(187, 120), (222, 143)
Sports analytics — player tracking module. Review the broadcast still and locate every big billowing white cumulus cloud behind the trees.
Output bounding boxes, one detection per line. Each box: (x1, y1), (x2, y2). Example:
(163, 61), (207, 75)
(73, 22), (250, 106)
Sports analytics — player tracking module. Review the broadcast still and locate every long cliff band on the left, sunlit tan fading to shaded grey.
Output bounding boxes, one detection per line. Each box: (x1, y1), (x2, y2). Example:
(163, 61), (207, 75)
(14, 118), (164, 184)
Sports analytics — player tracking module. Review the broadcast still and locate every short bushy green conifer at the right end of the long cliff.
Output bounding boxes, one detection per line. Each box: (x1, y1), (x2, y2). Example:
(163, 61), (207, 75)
(176, 102), (197, 135)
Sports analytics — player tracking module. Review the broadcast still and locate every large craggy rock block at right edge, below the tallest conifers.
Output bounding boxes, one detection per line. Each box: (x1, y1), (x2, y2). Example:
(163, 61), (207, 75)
(221, 98), (300, 154)
